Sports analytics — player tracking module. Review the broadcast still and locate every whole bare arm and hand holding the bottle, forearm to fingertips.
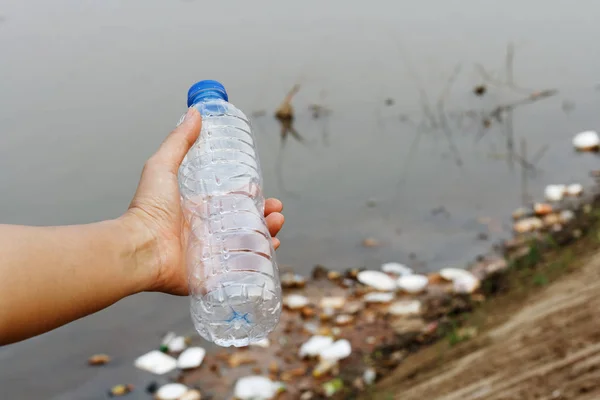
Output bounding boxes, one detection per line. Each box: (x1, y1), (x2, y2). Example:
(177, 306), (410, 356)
(0, 108), (284, 345)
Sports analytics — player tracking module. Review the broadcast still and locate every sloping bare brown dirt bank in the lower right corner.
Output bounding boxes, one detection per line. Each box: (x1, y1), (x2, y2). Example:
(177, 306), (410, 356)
(366, 222), (600, 400)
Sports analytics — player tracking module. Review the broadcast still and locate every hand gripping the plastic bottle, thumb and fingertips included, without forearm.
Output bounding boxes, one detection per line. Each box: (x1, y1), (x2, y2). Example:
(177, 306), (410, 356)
(121, 107), (284, 295)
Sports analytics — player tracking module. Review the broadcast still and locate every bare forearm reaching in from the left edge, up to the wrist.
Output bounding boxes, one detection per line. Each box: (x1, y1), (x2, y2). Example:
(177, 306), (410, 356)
(0, 220), (154, 345)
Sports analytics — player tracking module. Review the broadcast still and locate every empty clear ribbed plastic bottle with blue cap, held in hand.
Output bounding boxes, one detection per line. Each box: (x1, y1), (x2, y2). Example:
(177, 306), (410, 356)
(179, 80), (281, 347)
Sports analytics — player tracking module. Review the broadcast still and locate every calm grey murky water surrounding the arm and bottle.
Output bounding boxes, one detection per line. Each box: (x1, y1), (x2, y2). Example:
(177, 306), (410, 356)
(0, 0), (600, 399)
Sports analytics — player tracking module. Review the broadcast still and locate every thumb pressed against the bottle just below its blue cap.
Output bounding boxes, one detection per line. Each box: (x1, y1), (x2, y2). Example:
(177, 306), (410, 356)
(152, 107), (202, 173)
